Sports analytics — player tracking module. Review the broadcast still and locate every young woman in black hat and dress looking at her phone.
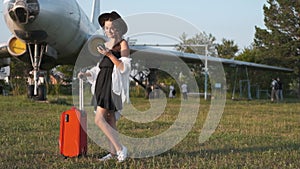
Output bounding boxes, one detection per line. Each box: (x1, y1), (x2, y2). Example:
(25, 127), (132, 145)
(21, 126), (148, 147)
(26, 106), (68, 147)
(95, 11), (131, 162)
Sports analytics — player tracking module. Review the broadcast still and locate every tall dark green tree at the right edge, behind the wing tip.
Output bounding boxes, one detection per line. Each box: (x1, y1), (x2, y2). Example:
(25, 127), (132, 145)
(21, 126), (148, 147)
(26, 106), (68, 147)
(254, 0), (300, 97)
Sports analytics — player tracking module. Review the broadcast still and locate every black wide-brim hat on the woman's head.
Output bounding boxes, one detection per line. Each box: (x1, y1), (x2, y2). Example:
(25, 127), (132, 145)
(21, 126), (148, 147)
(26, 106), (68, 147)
(98, 11), (128, 35)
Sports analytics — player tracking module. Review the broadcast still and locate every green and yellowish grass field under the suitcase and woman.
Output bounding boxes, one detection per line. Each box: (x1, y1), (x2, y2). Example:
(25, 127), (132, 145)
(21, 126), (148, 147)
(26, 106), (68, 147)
(0, 96), (300, 169)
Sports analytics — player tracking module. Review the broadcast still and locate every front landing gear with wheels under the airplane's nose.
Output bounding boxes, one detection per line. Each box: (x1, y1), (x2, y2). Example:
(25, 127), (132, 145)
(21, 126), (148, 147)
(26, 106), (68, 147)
(27, 44), (46, 101)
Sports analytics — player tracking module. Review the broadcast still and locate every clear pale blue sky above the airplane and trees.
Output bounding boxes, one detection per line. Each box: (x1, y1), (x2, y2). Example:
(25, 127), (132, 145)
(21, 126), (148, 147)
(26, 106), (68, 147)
(0, 0), (266, 50)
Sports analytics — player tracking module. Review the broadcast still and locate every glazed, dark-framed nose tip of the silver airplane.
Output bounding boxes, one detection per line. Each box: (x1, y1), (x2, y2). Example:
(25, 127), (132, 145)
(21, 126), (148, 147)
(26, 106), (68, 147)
(8, 0), (40, 25)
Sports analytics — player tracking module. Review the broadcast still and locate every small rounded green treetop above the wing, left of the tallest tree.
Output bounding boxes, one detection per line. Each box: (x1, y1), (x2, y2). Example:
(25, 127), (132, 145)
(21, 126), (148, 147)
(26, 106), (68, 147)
(216, 38), (239, 59)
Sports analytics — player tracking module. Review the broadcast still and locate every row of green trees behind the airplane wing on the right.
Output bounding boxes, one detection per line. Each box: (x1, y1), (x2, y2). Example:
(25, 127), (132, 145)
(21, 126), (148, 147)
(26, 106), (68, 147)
(177, 0), (300, 97)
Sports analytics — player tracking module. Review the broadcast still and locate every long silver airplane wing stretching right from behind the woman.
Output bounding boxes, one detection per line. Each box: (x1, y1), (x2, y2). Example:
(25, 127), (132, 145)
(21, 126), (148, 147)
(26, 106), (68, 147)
(130, 45), (294, 72)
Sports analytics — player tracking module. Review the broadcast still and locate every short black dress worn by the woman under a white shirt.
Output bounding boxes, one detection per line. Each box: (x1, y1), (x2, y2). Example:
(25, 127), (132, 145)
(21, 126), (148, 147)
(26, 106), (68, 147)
(95, 42), (122, 111)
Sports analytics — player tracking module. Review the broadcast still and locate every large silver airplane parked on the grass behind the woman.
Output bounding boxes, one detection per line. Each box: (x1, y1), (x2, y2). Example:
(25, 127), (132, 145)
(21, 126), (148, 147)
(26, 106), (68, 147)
(0, 0), (293, 98)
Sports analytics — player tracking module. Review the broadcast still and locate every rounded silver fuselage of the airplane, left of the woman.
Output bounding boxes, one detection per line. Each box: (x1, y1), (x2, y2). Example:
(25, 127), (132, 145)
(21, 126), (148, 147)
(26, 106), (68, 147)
(3, 0), (96, 64)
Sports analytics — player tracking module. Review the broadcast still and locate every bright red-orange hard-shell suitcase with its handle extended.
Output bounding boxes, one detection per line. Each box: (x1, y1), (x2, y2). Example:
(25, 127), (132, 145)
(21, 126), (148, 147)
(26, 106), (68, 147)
(59, 79), (87, 157)
